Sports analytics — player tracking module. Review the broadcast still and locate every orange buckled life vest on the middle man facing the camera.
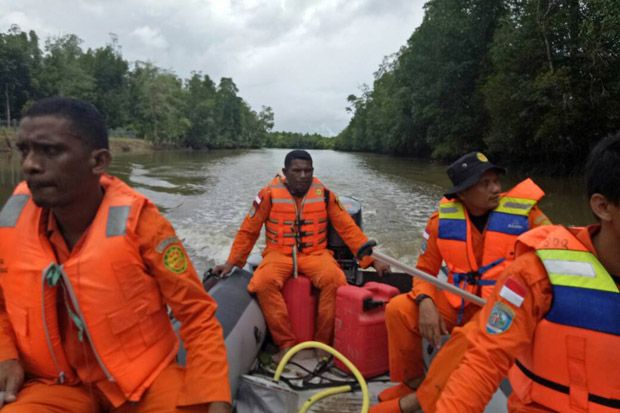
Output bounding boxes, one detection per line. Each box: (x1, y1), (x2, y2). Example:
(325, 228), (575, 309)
(265, 176), (328, 255)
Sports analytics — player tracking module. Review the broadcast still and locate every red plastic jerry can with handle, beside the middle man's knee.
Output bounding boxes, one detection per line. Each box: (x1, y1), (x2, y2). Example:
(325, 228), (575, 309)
(334, 282), (399, 378)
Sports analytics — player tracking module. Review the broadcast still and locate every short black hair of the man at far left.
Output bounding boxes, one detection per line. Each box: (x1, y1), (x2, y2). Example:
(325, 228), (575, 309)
(24, 96), (110, 149)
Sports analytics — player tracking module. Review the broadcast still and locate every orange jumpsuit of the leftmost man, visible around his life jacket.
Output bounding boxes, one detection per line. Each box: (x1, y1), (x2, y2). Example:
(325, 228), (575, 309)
(0, 196), (231, 413)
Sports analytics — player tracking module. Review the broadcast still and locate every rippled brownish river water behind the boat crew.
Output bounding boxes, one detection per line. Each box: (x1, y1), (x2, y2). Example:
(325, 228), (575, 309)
(0, 149), (592, 271)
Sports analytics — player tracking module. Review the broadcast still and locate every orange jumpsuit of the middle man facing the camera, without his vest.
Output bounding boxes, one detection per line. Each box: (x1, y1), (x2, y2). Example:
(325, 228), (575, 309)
(227, 179), (373, 348)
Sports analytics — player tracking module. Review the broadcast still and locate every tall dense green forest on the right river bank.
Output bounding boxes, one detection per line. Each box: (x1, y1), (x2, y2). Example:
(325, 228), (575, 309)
(335, 0), (620, 173)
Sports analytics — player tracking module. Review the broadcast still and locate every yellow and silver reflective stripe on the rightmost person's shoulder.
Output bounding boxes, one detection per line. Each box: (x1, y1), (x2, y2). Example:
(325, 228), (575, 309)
(536, 250), (619, 292)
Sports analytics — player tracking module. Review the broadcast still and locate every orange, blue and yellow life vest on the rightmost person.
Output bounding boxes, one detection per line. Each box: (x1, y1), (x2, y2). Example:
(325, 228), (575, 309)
(509, 226), (620, 413)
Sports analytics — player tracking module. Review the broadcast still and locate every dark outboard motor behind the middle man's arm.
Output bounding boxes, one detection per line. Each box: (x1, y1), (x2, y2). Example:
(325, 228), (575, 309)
(327, 196), (363, 285)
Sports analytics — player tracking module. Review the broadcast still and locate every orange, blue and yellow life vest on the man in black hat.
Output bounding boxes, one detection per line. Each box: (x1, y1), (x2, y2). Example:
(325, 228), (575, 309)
(437, 178), (544, 308)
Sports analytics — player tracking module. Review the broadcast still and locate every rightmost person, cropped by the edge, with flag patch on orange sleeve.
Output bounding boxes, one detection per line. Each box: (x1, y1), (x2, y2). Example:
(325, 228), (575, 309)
(436, 135), (620, 413)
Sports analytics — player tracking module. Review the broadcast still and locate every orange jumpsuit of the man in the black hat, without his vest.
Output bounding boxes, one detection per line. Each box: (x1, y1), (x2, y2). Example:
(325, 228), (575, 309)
(386, 206), (549, 384)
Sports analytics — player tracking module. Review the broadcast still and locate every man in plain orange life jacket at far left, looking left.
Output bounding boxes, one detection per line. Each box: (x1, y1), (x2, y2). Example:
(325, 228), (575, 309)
(0, 98), (231, 413)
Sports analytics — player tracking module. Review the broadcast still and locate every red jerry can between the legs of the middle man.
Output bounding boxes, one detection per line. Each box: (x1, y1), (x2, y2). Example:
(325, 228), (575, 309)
(282, 275), (317, 343)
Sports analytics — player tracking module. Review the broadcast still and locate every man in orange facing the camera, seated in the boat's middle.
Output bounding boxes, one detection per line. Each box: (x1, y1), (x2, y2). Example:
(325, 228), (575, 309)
(215, 150), (389, 353)
